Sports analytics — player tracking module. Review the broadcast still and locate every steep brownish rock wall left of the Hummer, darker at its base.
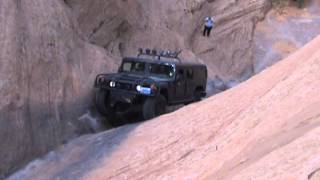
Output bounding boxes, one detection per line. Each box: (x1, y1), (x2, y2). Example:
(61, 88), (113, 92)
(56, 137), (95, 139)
(0, 0), (115, 178)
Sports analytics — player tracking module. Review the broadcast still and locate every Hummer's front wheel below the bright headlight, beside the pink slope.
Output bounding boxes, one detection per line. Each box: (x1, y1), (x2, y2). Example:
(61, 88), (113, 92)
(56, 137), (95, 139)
(142, 95), (167, 120)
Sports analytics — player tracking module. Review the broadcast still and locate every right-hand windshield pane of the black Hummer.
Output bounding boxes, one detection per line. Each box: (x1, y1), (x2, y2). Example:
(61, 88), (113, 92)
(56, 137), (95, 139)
(149, 64), (174, 78)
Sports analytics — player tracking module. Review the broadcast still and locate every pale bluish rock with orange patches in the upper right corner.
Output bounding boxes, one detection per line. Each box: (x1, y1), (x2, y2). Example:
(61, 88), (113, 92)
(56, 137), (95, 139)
(253, 0), (320, 73)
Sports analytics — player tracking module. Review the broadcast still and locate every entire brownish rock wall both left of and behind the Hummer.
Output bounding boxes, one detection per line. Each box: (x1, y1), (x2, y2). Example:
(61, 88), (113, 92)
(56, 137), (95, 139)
(0, 0), (270, 175)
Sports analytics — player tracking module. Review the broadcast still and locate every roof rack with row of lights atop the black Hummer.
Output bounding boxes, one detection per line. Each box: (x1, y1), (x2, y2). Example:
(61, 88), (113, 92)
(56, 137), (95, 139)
(138, 48), (182, 62)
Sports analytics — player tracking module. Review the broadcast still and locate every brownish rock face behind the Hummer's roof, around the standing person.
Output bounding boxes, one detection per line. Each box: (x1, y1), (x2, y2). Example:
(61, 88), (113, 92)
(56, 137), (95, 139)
(66, 0), (270, 81)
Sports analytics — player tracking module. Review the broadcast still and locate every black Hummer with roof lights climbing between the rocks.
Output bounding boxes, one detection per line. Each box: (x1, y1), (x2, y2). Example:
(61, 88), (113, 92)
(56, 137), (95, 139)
(94, 49), (207, 125)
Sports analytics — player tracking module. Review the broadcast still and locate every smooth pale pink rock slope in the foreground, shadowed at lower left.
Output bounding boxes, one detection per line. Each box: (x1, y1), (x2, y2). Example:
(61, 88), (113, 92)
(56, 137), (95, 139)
(9, 36), (320, 180)
